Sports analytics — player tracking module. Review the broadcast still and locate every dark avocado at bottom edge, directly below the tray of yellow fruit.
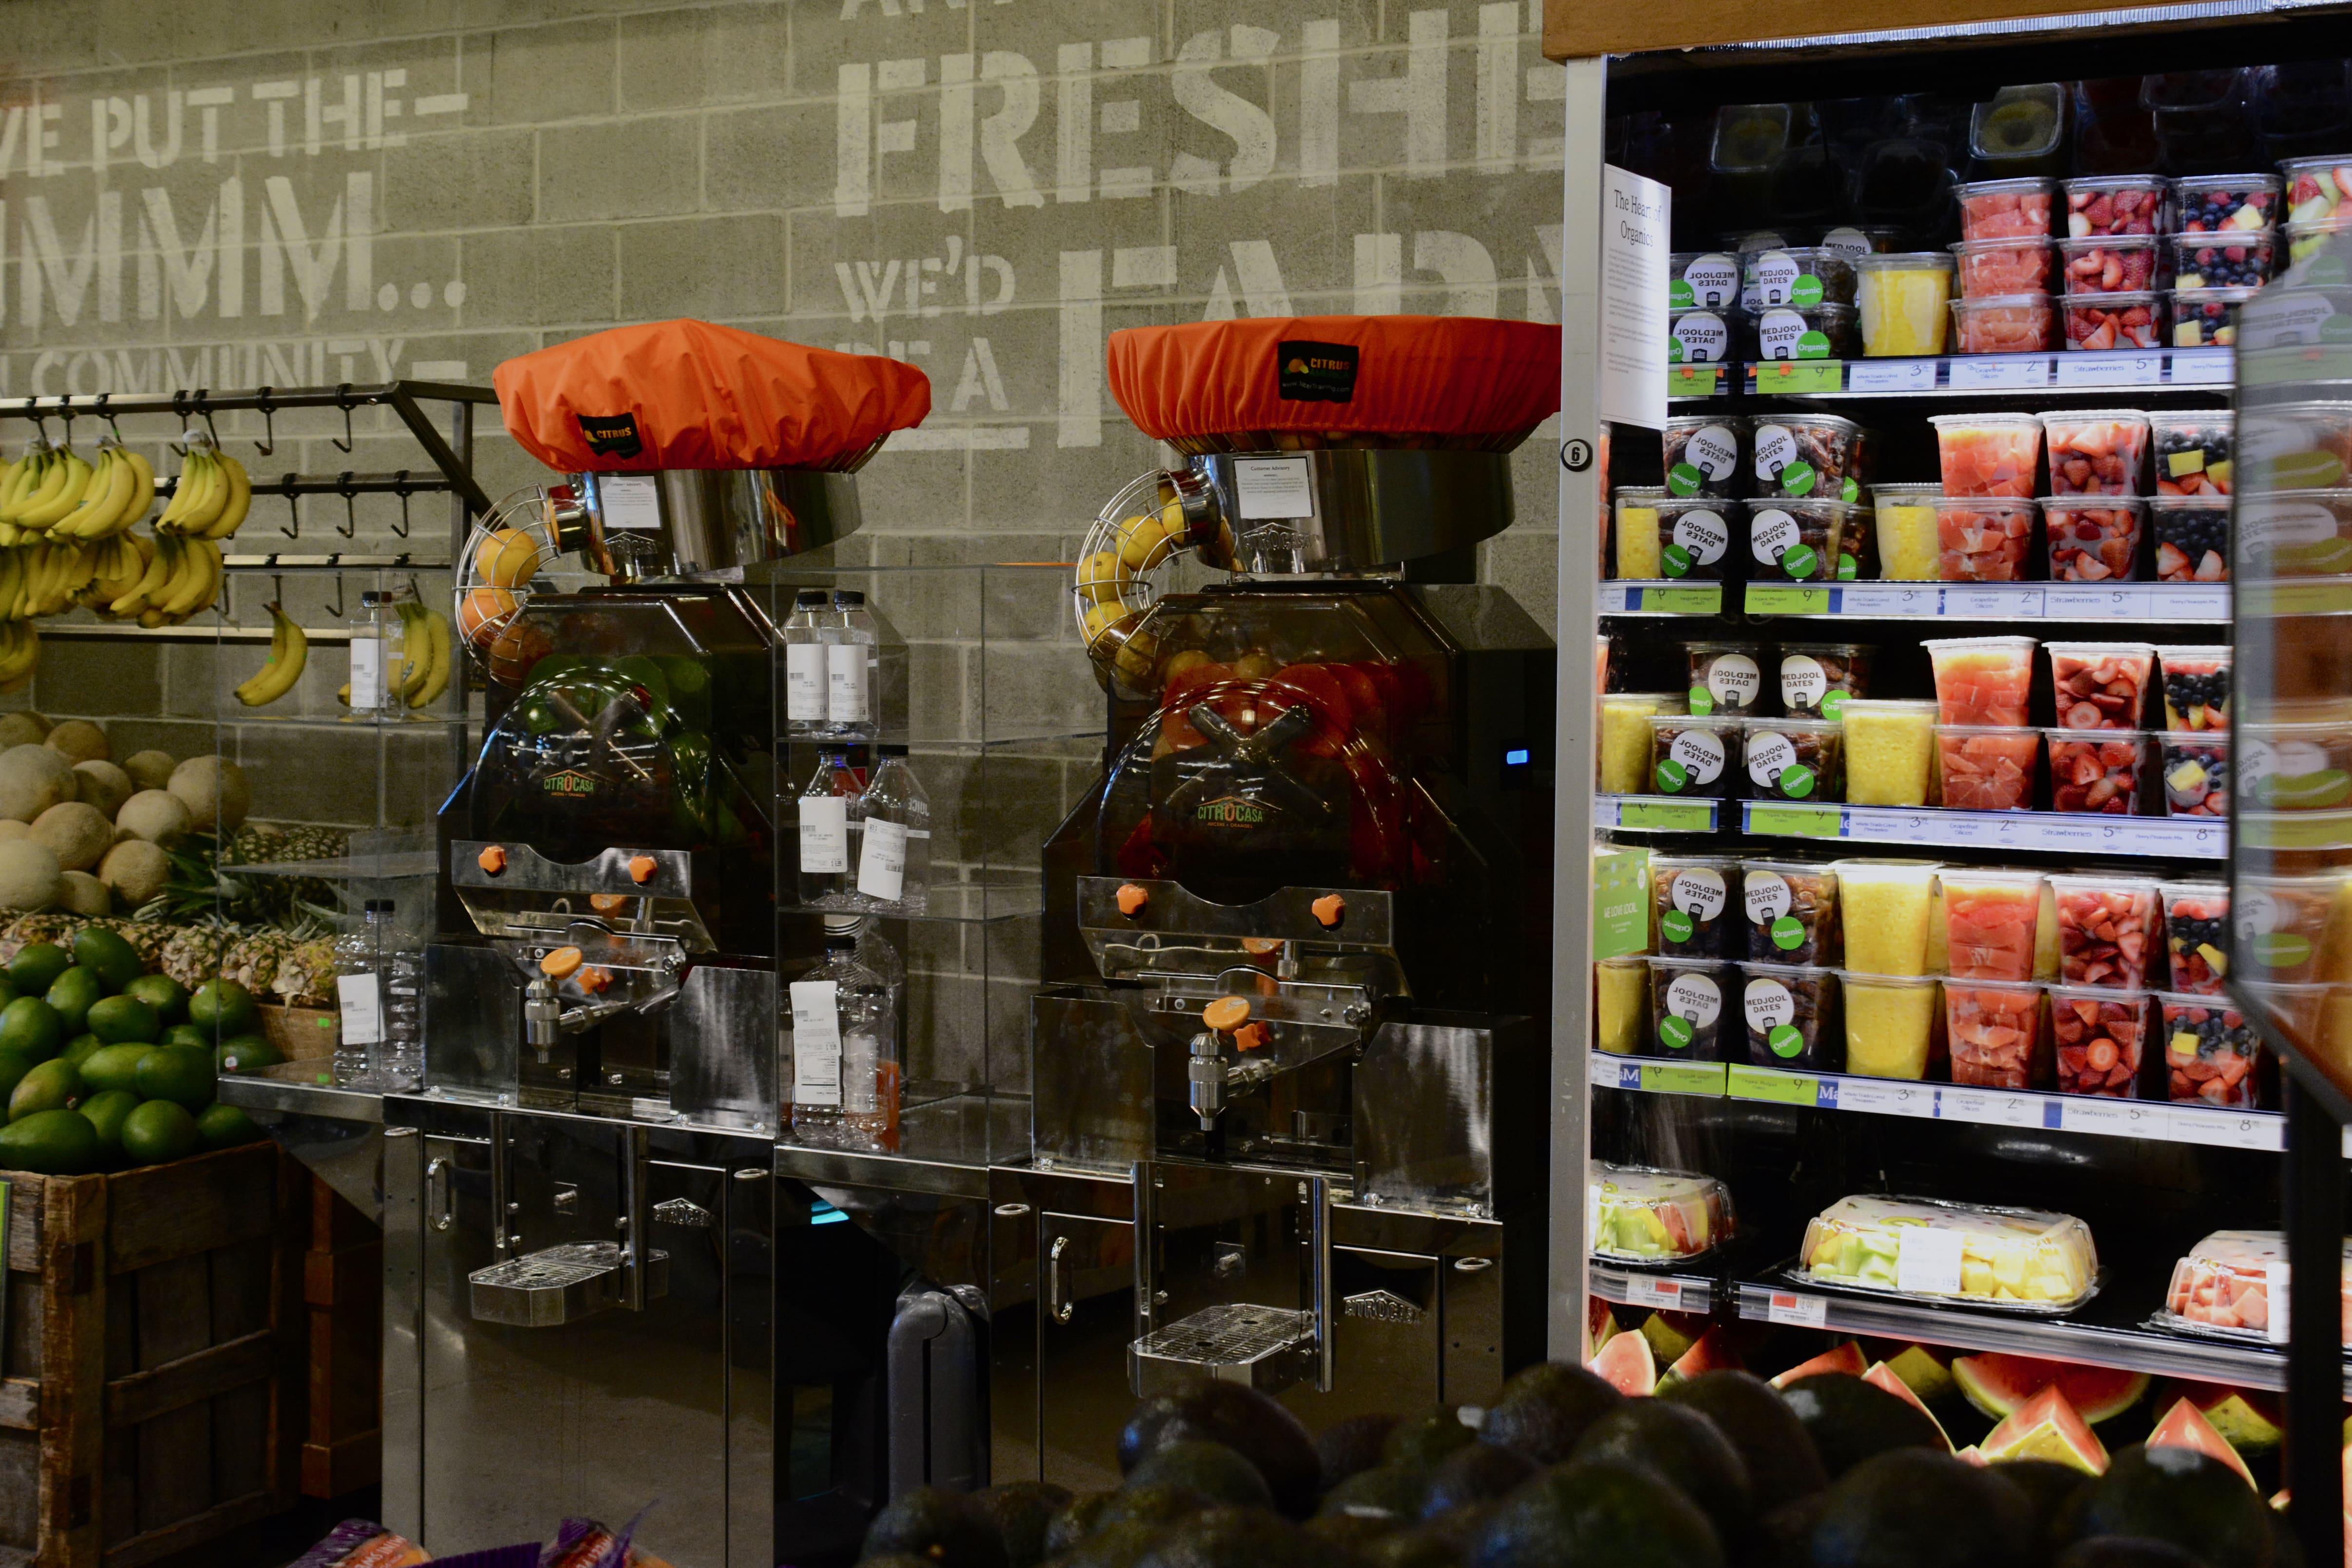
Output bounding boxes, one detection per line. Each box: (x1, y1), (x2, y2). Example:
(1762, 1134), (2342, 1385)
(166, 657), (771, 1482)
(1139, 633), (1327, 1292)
(1804, 1457), (2041, 1568)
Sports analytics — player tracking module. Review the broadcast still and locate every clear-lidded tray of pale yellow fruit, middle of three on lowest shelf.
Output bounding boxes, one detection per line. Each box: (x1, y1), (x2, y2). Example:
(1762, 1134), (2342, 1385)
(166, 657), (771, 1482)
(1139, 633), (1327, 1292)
(1795, 1196), (2098, 1314)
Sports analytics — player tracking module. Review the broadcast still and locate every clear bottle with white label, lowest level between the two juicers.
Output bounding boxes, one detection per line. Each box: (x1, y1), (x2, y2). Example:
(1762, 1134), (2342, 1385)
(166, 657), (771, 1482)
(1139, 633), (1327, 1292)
(786, 914), (901, 1150)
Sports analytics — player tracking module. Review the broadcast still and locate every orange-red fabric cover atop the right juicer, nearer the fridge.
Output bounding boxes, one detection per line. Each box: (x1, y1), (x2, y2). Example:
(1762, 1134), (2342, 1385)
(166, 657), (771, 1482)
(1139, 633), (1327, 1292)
(1105, 315), (1559, 442)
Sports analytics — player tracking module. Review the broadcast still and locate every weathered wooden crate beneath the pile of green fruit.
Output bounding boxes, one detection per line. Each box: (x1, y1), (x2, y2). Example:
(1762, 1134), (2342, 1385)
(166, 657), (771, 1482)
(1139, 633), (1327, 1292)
(0, 1142), (308, 1568)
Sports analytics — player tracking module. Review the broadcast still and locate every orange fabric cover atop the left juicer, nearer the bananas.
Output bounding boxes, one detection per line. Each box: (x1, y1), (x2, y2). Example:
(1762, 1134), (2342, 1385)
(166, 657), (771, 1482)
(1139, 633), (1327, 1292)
(492, 320), (931, 472)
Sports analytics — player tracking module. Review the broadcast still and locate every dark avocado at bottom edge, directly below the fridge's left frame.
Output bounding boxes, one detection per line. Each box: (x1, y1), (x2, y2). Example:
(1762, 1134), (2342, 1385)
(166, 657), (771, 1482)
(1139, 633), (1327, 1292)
(1468, 1460), (1724, 1568)
